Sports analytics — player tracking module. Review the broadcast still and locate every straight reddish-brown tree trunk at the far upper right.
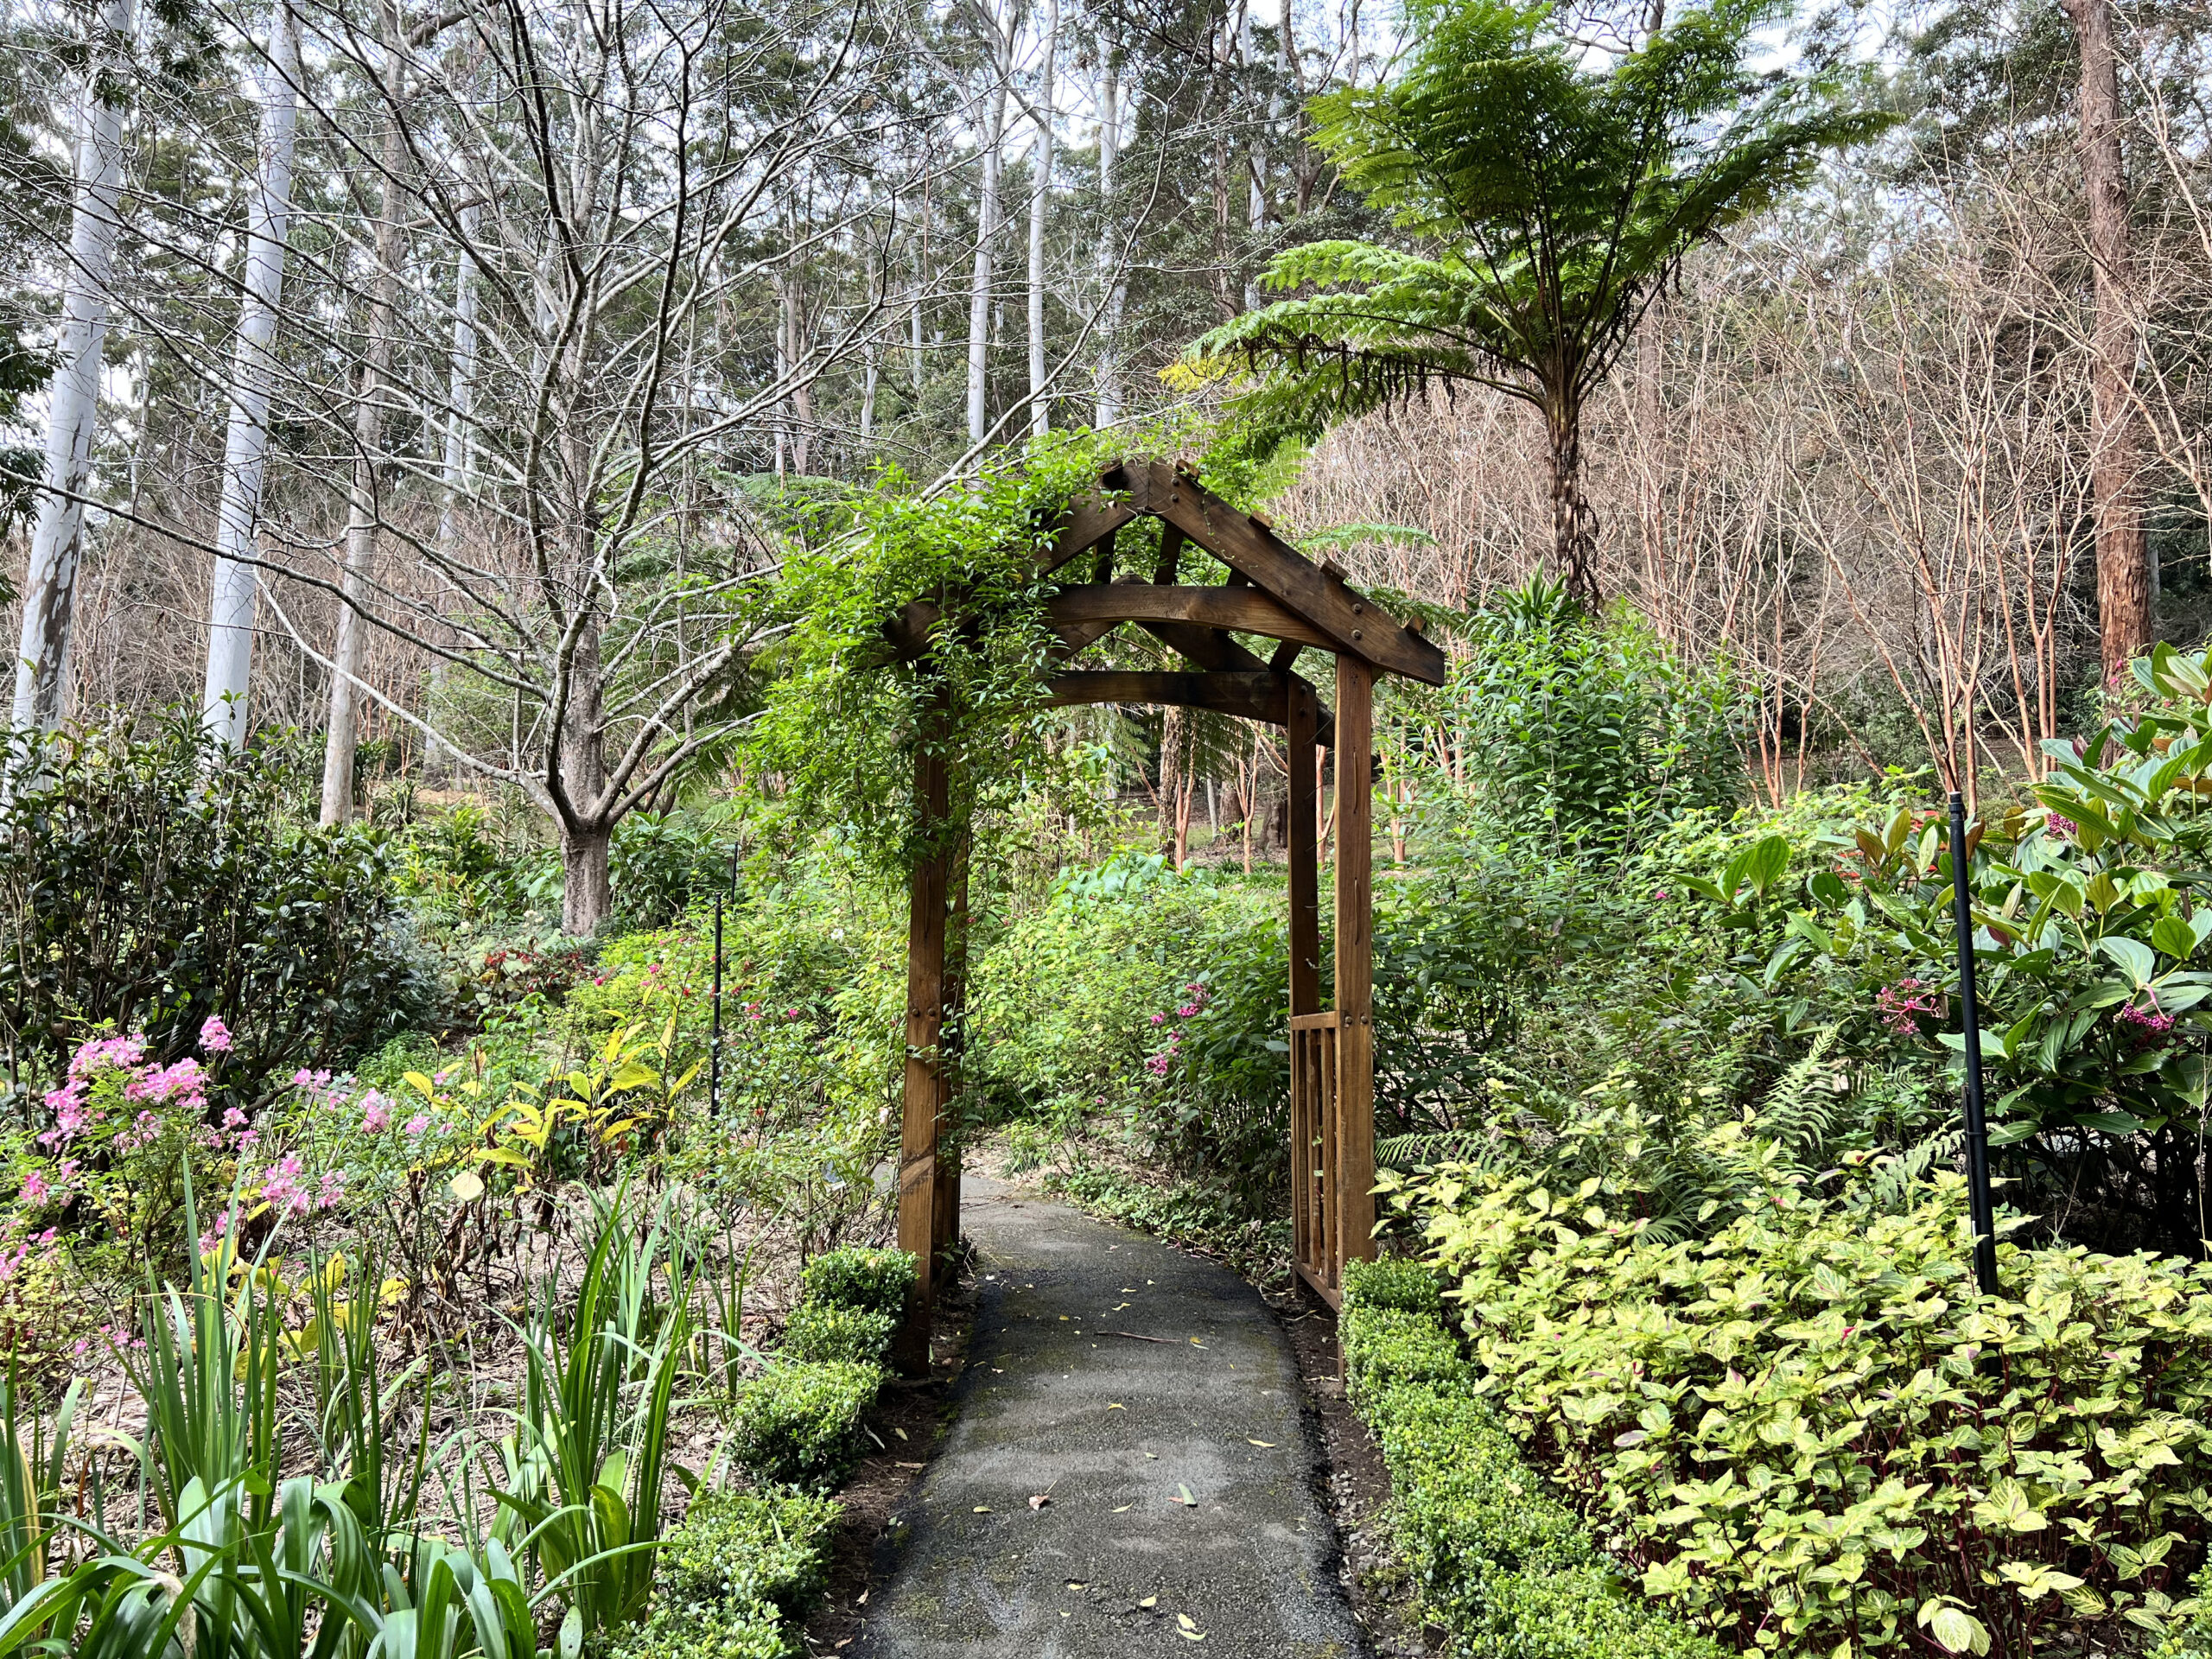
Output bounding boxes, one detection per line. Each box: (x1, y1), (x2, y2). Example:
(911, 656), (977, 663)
(2063, 0), (2150, 681)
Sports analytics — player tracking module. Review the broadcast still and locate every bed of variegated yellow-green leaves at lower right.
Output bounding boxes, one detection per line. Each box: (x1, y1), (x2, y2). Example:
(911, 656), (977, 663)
(1394, 1154), (2212, 1655)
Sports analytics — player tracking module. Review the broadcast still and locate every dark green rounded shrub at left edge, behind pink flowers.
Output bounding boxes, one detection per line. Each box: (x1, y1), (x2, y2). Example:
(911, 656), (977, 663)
(0, 708), (435, 1106)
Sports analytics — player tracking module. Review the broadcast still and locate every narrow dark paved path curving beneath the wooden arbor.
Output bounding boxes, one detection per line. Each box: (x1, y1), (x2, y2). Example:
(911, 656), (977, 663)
(847, 1177), (1367, 1659)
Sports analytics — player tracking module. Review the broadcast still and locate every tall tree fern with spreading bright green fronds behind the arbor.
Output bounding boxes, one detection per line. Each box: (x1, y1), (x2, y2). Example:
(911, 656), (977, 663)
(1197, 0), (1889, 606)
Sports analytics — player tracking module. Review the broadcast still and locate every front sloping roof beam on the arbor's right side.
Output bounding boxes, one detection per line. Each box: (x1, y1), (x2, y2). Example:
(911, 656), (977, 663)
(1123, 460), (1451, 686)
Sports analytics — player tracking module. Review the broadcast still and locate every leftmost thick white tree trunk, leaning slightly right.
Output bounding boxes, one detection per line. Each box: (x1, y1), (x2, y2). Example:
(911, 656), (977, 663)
(13, 0), (135, 732)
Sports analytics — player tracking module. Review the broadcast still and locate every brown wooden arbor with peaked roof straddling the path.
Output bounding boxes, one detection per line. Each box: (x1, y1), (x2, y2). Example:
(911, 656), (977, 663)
(889, 460), (1446, 1370)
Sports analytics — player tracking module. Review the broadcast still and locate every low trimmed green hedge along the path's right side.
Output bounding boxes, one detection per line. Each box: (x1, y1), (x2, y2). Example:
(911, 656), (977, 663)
(1338, 1261), (1727, 1659)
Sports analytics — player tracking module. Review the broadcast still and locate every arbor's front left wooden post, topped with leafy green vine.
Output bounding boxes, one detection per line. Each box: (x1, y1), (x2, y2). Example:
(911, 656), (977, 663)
(893, 739), (951, 1376)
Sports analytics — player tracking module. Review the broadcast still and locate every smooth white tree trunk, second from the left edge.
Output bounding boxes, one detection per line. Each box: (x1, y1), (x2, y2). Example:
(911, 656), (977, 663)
(199, 0), (299, 747)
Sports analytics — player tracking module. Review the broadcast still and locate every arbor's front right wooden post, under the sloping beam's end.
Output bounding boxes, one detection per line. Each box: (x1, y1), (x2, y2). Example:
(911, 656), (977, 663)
(1336, 657), (1376, 1261)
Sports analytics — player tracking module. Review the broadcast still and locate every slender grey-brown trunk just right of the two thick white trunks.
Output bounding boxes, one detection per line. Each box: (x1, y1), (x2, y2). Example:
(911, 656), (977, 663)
(321, 30), (407, 823)
